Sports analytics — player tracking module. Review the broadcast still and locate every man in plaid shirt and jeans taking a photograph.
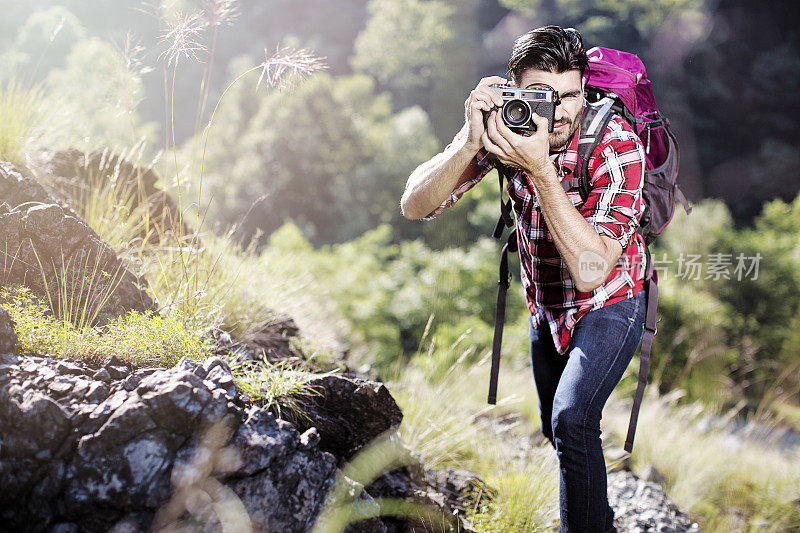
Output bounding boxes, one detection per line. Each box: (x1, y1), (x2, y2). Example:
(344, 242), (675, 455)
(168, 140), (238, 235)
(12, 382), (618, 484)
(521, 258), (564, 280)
(401, 26), (646, 532)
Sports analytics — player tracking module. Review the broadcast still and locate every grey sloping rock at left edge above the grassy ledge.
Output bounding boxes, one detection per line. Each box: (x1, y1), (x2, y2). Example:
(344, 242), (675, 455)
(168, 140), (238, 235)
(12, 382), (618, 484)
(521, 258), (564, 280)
(0, 162), (155, 320)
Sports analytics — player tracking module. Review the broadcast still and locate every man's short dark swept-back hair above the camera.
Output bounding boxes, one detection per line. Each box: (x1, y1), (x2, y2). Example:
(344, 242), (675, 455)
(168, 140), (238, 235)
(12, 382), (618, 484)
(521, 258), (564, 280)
(508, 25), (589, 83)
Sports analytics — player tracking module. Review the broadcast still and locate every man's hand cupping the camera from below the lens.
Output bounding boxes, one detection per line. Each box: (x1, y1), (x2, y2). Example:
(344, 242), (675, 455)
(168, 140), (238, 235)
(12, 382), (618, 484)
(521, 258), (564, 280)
(481, 111), (552, 180)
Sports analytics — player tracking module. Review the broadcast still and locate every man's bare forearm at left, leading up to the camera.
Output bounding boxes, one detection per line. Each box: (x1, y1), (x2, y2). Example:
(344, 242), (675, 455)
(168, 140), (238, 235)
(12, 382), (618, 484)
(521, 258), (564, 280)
(400, 128), (478, 220)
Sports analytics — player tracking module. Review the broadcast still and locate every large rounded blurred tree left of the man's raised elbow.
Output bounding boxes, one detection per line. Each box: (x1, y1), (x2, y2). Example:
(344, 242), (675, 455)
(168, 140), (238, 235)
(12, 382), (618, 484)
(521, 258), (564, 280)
(187, 67), (436, 244)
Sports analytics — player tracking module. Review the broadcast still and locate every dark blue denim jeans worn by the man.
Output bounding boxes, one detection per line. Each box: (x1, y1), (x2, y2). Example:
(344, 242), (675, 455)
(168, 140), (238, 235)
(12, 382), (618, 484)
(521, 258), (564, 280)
(528, 289), (647, 533)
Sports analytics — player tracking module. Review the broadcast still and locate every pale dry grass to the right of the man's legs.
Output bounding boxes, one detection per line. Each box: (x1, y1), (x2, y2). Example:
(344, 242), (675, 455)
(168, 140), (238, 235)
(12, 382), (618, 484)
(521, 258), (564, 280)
(607, 389), (800, 533)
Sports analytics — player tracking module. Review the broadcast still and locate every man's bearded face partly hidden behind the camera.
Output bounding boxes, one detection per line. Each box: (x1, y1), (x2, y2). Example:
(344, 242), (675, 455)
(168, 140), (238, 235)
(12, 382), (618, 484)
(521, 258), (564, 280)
(519, 68), (583, 150)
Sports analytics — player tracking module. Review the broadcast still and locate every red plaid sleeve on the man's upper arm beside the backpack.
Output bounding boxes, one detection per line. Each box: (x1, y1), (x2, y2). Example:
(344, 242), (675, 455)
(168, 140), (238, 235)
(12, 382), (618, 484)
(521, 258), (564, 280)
(580, 126), (645, 250)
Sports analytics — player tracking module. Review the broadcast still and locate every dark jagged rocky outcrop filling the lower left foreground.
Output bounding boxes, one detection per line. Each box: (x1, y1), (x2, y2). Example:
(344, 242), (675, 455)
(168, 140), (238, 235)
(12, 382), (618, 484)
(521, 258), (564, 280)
(0, 310), (479, 533)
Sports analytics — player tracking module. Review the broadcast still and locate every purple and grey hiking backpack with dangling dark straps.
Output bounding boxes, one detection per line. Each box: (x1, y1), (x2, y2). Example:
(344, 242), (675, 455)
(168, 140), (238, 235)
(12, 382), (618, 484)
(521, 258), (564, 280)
(488, 47), (692, 453)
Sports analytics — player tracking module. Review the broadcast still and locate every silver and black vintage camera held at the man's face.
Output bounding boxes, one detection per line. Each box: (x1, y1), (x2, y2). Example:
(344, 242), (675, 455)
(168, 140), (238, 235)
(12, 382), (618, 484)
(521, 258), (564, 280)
(483, 85), (561, 133)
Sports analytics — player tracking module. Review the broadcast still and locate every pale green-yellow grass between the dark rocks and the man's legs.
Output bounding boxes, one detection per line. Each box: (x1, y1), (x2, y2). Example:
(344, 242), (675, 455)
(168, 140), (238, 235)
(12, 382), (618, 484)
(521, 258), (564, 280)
(388, 337), (558, 532)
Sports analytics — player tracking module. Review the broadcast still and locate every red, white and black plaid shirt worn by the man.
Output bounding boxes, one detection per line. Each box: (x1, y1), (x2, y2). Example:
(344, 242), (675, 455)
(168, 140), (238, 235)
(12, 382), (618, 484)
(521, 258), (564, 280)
(423, 108), (646, 355)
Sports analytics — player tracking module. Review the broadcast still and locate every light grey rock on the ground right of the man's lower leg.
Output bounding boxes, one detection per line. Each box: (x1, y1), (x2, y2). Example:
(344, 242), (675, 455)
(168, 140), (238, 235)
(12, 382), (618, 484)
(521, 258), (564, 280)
(608, 470), (700, 533)
